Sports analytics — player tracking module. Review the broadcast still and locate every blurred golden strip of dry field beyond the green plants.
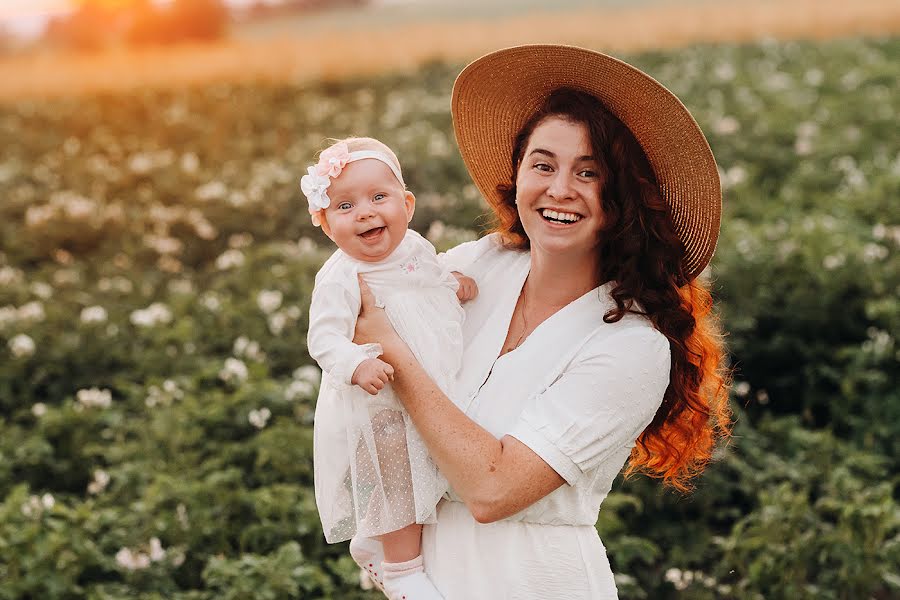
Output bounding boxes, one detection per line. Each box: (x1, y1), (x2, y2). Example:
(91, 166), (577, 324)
(0, 0), (900, 101)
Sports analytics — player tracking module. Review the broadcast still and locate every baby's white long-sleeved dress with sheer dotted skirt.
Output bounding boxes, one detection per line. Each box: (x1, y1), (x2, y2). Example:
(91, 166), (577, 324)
(307, 230), (464, 543)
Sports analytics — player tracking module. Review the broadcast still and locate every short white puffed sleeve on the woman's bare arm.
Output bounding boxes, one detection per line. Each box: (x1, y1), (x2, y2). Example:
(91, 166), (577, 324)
(509, 327), (671, 485)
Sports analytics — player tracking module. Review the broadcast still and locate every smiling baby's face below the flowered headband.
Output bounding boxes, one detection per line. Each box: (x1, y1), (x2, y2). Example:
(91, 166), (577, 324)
(322, 158), (416, 262)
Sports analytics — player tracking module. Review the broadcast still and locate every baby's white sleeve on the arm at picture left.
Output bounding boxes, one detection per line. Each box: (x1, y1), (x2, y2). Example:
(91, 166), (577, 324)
(306, 283), (382, 386)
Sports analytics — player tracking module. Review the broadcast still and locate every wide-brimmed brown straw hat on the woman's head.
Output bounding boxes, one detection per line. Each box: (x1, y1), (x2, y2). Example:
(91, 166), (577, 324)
(452, 44), (722, 279)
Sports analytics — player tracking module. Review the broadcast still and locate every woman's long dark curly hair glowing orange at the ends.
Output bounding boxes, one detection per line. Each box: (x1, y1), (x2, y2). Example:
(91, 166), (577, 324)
(493, 88), (731, 491)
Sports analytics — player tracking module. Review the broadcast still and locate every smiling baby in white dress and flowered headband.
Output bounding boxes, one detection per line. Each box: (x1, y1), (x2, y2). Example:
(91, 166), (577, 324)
(300, 138), (477, 600)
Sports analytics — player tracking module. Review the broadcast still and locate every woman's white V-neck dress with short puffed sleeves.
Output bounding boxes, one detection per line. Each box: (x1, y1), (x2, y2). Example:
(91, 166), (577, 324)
(423, 236), (670, 600)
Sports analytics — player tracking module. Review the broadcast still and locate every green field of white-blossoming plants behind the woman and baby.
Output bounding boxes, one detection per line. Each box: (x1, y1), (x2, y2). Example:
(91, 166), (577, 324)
(0, 38), (900, 600)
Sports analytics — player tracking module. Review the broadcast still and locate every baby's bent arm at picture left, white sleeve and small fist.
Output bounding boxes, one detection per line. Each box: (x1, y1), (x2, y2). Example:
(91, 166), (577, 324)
(307, 283), (393, 395)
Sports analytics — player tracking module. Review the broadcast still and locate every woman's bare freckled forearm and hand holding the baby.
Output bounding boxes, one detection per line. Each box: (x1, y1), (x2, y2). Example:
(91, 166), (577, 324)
(354, 278), (565, 523)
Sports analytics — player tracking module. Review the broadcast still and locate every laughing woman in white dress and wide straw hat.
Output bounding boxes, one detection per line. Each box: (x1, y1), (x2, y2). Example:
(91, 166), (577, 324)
(355, 45), (730, 600)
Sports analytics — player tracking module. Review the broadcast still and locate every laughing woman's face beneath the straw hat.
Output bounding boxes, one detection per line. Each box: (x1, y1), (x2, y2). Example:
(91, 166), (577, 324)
(516, 117), (603, 257)
